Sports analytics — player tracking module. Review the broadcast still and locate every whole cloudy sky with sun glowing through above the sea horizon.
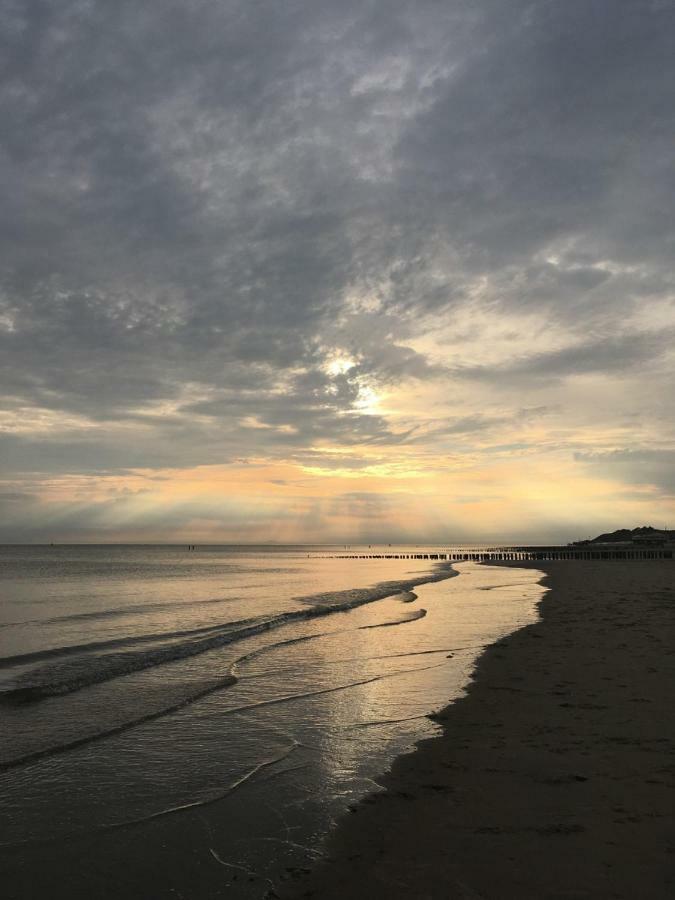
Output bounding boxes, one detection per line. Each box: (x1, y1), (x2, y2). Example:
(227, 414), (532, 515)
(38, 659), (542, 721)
(0, 0), (675, 543)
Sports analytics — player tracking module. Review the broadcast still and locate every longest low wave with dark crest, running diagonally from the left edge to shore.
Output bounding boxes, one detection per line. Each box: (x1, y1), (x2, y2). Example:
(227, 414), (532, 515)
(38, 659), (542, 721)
(0, 564), (456, 705)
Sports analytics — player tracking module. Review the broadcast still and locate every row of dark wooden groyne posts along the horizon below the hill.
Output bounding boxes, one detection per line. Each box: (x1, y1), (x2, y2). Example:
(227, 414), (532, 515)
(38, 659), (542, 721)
(334, 547), (673, 562)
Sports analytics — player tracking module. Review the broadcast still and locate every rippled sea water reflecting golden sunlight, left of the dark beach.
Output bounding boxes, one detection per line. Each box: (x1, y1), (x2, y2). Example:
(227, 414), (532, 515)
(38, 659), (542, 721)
(0, 546), (544, 900)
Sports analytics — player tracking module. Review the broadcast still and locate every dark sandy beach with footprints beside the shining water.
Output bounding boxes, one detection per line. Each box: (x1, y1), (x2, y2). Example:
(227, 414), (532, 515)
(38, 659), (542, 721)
(286, 561), (675, 900)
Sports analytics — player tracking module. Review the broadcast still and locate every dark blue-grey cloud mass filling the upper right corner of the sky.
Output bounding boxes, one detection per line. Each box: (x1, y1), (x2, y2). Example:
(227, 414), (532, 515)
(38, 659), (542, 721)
(401, 0), (675, 265)
